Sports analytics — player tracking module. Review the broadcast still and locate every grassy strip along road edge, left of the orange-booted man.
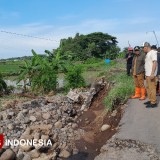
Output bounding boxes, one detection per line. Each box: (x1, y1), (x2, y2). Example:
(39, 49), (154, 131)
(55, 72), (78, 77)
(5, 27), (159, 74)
(104, 60), (134, 111)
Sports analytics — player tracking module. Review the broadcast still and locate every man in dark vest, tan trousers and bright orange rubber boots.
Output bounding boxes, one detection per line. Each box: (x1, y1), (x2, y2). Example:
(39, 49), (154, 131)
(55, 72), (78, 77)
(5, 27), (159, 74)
(131, 46), (146, 100)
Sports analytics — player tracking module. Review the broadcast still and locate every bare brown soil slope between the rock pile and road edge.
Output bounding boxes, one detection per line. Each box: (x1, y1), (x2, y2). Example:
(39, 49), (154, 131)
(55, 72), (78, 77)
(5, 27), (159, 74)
(67, 88), (122, 160)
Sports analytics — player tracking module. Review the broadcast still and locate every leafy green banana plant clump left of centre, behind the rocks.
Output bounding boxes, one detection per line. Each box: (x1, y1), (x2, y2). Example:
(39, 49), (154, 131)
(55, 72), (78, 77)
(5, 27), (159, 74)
(19, 50), (60, 92)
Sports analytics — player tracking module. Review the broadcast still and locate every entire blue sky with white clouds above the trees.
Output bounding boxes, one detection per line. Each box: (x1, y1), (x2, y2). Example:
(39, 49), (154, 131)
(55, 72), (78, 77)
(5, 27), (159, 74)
(0, 0), (160, 59)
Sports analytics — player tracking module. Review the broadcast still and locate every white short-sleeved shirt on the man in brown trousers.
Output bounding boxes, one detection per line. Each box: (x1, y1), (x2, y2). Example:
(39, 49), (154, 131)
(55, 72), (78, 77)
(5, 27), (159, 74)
(145, 50), (157, 76)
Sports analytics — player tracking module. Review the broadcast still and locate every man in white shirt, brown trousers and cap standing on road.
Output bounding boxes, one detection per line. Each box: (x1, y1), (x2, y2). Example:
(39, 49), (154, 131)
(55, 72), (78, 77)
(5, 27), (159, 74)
(143, 42), (157, 108)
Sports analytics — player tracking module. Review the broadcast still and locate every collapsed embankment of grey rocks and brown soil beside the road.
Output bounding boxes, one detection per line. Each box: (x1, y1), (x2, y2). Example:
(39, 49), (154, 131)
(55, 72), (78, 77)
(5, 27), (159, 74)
(0, 78), (124, 160)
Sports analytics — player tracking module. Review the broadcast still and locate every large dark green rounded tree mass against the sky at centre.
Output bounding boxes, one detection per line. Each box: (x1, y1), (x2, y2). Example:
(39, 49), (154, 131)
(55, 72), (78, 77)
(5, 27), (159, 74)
(58, 32), (118, 60)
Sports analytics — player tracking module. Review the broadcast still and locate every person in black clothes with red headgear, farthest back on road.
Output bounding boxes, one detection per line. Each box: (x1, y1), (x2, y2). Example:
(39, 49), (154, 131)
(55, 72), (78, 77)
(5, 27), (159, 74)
(125, 47), (133, 76)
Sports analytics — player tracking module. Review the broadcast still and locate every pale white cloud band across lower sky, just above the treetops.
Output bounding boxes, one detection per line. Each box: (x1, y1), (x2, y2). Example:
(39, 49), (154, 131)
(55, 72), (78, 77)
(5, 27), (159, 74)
(0, 17), (160, 58)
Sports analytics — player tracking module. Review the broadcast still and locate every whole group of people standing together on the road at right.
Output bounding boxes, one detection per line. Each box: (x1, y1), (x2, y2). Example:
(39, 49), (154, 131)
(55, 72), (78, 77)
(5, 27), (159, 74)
(125, 42), (160, 108)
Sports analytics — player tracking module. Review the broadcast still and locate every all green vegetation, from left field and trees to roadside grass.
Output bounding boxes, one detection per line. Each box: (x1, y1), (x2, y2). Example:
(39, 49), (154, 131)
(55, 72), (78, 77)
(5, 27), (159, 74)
(0, 32), (133, 110)
